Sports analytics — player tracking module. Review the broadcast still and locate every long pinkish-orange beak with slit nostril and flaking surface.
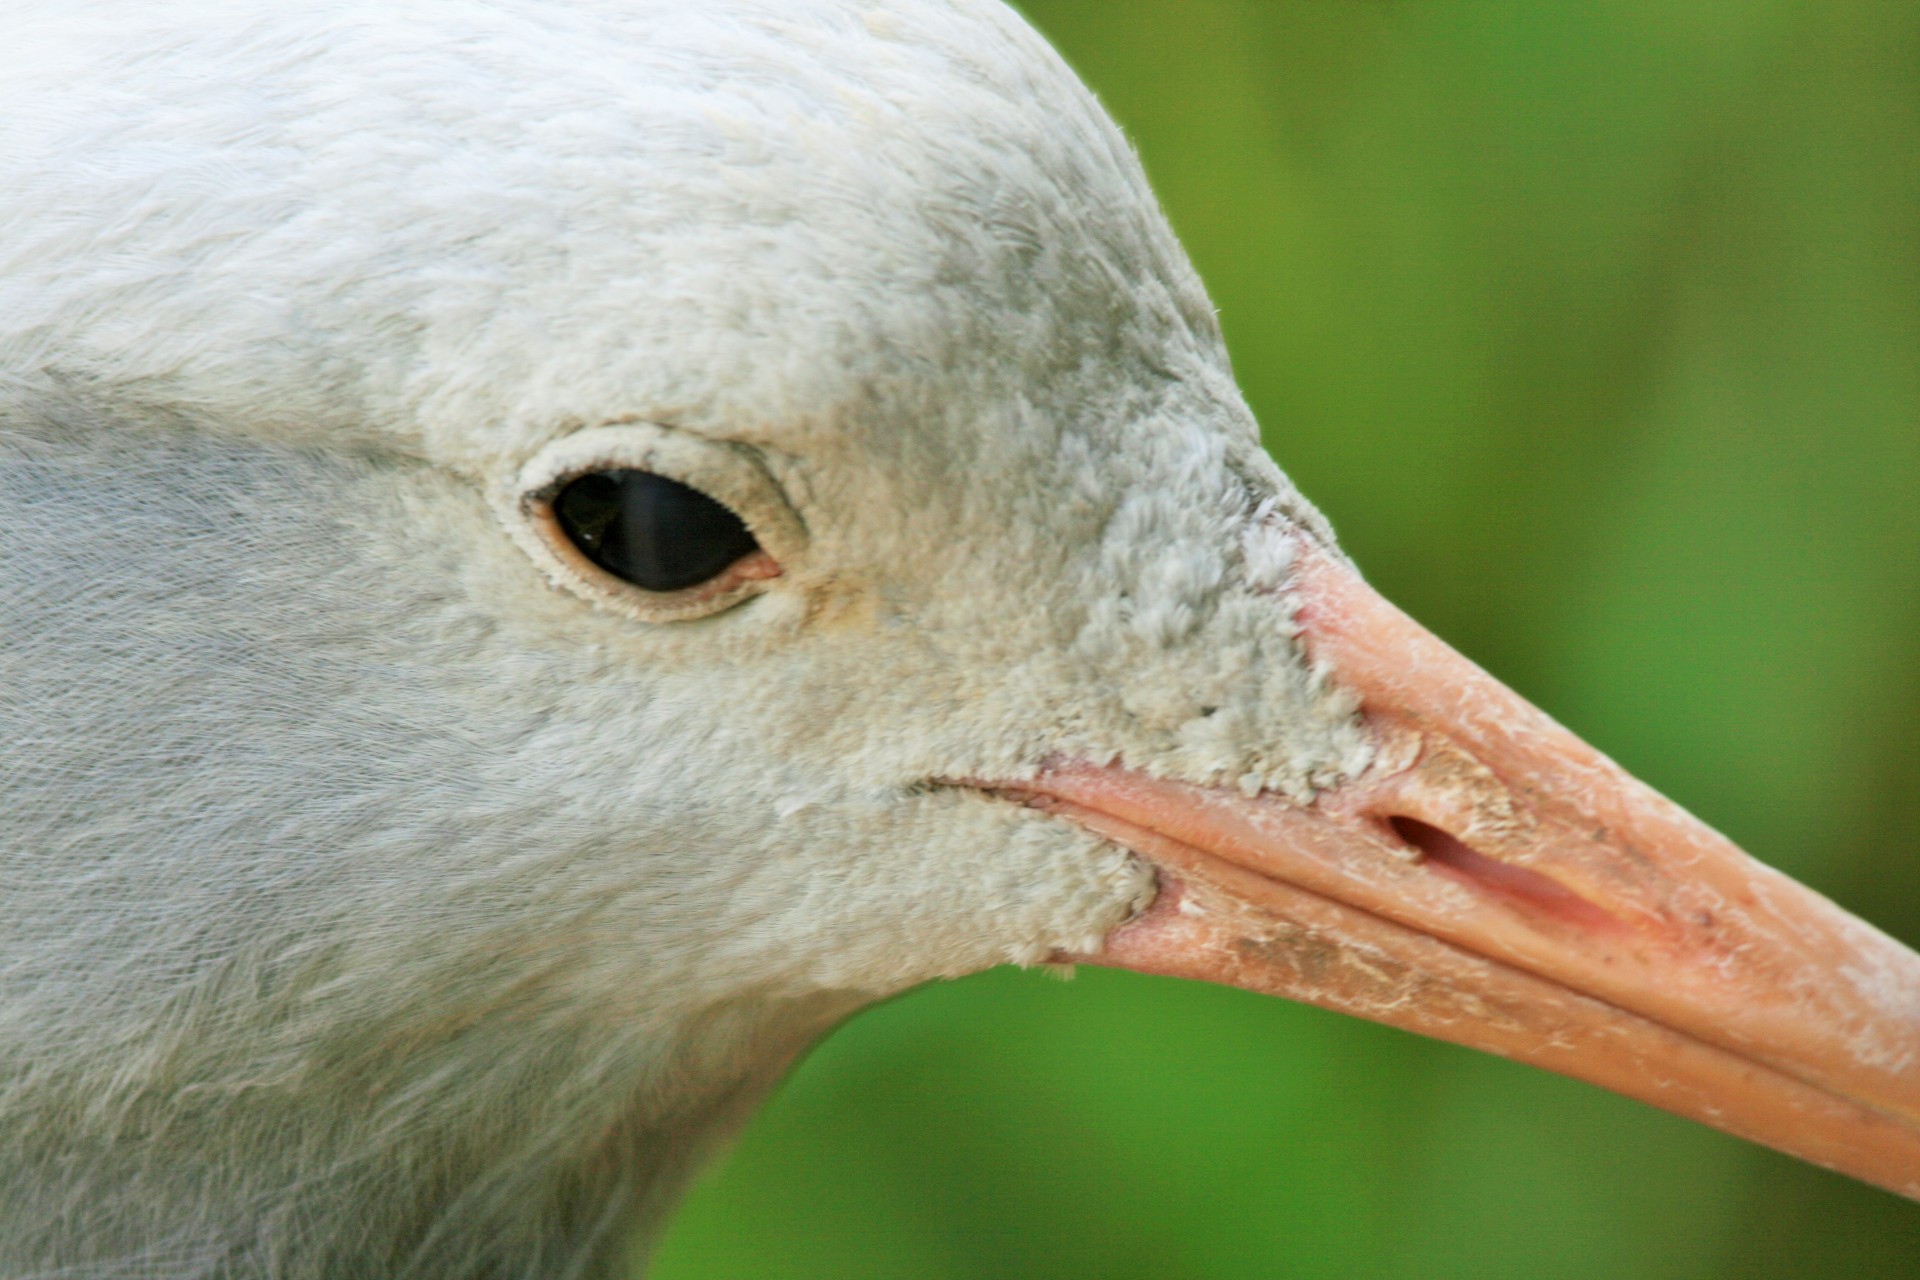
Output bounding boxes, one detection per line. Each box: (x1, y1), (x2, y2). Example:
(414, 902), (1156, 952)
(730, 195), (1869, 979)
(998, 529), (1920, 1197)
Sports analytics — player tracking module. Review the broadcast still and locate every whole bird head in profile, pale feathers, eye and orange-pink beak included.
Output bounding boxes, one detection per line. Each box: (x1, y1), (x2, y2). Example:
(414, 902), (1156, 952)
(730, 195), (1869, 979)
(0, 0), (1920, 1274)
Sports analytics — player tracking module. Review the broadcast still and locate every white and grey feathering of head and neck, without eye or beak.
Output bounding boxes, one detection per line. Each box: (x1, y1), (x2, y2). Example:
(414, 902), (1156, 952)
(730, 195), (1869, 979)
(0, 0), (1365, 1280)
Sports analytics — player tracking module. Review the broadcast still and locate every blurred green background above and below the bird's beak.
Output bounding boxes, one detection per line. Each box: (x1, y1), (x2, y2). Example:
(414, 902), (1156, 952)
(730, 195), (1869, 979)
(655, 0), (1920, 1280)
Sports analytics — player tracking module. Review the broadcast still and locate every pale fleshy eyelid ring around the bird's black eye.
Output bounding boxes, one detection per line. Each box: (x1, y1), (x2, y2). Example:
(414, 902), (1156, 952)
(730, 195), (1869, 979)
(497, 422), (806, 622)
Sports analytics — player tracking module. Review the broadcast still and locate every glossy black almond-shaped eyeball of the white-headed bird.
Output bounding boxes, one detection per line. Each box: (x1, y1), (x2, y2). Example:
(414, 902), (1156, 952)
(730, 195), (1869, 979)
(553, 470), (758, 591)
